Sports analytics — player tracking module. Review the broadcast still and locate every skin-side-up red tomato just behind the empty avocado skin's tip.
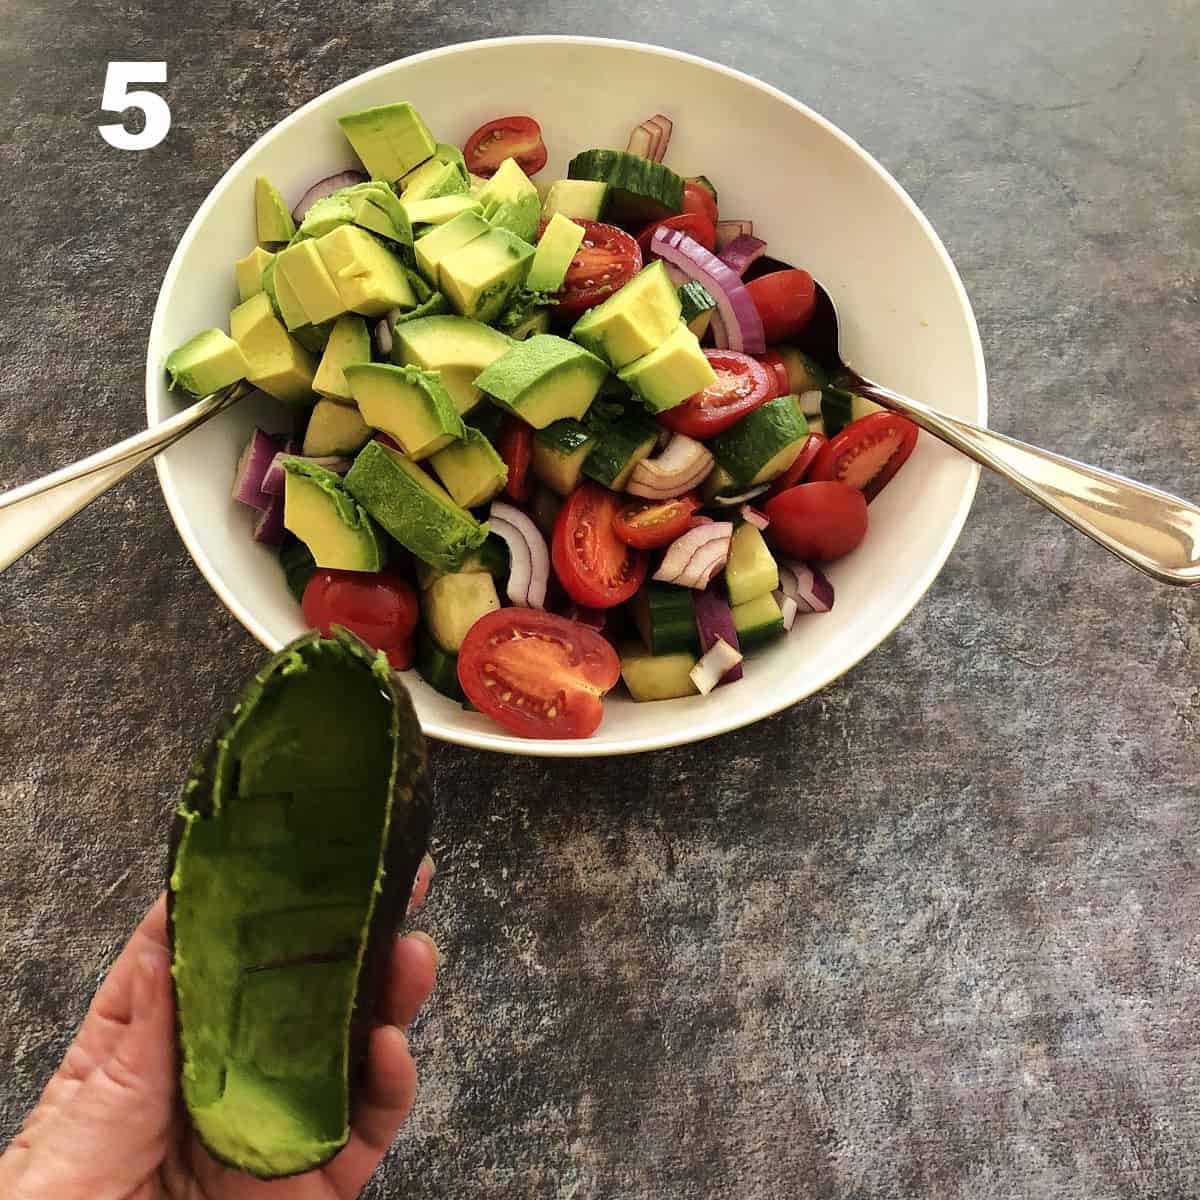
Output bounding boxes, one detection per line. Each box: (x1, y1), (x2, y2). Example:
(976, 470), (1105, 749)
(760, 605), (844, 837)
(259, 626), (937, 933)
(300, 568), (420, 666)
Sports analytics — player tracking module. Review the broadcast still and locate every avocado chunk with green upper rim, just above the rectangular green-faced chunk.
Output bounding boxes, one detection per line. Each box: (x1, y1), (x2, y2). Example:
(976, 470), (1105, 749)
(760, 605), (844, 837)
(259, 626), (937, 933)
(344, 362), (466, 461)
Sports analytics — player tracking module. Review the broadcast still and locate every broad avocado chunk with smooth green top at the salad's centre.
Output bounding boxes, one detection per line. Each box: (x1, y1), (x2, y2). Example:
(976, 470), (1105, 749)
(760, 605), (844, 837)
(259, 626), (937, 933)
(475, 334), (608, 430)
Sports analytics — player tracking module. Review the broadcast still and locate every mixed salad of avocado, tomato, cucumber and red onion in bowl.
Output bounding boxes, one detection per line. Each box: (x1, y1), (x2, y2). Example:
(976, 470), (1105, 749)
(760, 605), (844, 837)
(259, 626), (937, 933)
(166, 103), (917, 738)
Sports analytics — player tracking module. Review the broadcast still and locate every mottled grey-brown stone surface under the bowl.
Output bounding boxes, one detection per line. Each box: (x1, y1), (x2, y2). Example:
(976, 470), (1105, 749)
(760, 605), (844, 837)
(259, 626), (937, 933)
(0, 0), (1200, 1200)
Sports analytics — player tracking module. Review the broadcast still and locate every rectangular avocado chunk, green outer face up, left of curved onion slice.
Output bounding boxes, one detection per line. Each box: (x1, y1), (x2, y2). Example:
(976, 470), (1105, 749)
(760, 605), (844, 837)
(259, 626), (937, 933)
(346, 442), (487, 571)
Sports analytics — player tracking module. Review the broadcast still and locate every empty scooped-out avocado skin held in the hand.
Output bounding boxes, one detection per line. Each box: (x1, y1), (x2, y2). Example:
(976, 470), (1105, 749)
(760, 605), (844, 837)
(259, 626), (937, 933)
(168, 628), (432, 1178)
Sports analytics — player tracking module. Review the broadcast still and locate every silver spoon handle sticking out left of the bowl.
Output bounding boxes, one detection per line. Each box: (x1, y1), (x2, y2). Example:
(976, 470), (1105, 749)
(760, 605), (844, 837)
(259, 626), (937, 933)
(0, 384), (246, 571)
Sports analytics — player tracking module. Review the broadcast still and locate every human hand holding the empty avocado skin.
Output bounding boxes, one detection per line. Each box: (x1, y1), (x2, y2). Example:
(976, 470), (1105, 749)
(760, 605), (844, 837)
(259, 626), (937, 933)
(0, 858), (438, 1200)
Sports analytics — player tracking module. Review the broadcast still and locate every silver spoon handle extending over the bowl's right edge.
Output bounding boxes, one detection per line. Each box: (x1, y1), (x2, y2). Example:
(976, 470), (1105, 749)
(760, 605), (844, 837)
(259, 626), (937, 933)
(857, 379), (1200, 587)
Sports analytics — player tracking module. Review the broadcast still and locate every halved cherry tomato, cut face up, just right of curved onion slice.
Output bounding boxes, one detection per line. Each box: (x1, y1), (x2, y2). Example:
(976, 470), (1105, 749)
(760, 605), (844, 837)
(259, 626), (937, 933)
(551, 484), (649, 608)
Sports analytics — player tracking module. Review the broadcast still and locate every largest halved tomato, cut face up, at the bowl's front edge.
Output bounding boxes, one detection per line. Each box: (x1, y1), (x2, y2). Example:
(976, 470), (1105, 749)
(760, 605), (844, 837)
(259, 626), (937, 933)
(458, 608), (620, 738)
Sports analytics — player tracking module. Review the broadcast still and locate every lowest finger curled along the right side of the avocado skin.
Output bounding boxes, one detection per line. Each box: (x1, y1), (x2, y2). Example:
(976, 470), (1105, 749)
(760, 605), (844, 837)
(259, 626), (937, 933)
(325, 1025), (416, 1200)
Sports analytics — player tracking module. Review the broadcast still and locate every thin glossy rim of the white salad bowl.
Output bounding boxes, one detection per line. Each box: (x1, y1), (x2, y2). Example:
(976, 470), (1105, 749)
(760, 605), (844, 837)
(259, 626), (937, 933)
(145, 34), (988, 758)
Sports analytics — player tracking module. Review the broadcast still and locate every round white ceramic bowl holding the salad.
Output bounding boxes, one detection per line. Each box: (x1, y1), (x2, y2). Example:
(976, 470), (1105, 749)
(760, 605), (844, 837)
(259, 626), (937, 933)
(146, 37), (986, 756)
